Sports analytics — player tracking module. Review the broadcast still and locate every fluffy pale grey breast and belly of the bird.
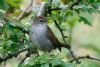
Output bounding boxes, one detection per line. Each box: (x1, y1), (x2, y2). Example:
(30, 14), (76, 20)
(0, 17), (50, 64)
(30, 24), (53, 51)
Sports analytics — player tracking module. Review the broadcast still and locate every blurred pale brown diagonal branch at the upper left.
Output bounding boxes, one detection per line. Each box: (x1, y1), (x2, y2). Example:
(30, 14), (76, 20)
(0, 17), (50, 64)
(17, 0), (33, 21)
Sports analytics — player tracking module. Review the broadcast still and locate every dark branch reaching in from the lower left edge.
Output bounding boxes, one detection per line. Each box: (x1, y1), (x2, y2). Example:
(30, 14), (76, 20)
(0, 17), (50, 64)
(0, 48), (30, 63)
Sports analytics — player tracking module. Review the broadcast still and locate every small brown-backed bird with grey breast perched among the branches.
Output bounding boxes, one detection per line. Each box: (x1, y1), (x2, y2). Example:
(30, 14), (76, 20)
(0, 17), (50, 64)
(29, 1), (70, 52)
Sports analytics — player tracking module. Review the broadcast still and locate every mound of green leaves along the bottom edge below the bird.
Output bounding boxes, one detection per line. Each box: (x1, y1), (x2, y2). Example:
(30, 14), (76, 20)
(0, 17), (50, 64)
(19, 54), (75, 67)
